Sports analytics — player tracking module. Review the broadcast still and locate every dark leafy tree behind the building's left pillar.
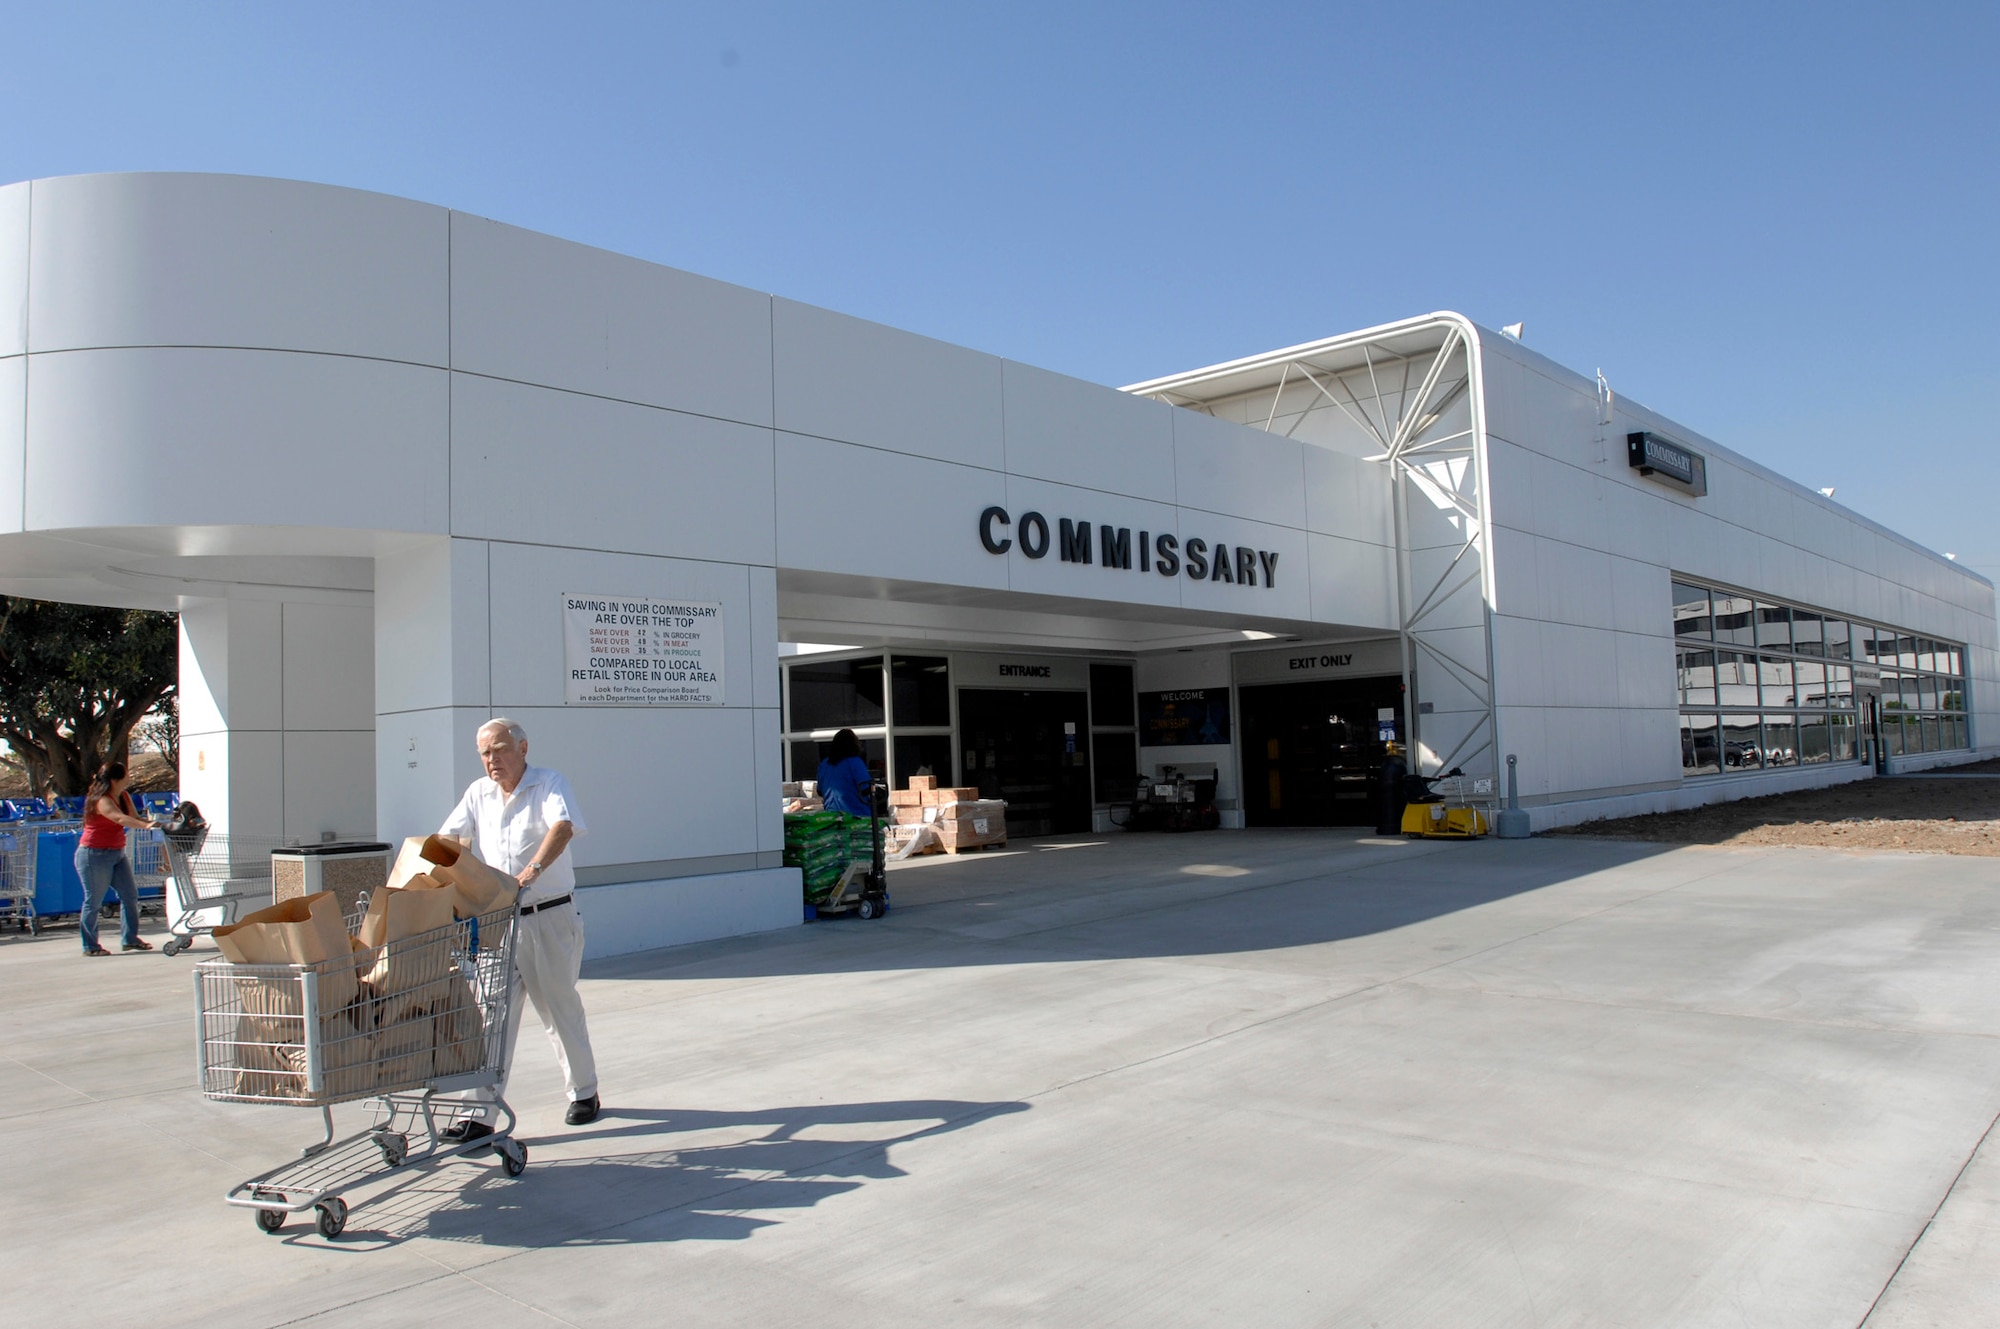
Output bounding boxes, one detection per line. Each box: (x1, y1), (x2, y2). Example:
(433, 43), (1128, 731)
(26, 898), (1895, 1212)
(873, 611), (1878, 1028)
(0, 596), (180, 795)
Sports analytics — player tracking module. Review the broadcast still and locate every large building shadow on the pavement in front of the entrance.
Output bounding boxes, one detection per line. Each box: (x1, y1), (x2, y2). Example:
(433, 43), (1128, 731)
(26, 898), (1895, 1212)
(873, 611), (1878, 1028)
(584, 831), (1674, 979)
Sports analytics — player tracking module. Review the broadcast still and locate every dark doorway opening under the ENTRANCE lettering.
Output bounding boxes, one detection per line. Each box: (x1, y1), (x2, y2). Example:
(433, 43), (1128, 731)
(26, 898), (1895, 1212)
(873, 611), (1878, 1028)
(958, 689), (1090, 835)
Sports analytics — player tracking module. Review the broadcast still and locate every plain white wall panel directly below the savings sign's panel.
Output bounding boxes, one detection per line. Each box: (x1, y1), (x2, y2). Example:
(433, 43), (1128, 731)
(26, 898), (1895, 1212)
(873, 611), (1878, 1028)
(490, 707), (756, 867)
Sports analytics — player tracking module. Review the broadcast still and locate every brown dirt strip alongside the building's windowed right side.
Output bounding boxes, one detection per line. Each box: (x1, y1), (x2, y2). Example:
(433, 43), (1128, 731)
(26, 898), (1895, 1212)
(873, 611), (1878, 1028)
(1546, 761), (2000, 859)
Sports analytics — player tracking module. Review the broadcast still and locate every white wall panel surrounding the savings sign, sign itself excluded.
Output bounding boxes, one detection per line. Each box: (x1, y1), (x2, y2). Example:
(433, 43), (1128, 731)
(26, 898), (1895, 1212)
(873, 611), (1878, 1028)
(492, 540), (756, 719)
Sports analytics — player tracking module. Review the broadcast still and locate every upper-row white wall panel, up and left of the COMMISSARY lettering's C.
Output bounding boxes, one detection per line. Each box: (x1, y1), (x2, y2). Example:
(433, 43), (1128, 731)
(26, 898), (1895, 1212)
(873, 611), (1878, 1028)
(772, 300), (1004, 470)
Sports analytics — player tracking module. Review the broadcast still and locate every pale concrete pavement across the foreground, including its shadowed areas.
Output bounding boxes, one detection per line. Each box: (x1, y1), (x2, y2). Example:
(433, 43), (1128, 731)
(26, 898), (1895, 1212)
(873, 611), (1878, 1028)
(0, 831), (2000, 1327)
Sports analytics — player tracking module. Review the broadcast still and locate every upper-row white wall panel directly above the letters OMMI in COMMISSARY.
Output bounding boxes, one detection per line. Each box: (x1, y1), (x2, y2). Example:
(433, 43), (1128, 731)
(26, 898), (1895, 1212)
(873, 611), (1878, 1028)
(1002, 360), (1176, 506)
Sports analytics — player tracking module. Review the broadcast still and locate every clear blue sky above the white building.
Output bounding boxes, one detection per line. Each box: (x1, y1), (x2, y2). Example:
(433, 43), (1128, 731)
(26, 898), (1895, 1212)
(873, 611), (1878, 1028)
(0, 0), (2000, 576)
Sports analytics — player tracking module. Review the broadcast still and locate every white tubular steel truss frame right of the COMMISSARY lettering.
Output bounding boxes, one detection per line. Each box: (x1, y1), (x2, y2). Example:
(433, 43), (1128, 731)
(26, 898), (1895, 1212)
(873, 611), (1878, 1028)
(1134, 314), (1500, 807)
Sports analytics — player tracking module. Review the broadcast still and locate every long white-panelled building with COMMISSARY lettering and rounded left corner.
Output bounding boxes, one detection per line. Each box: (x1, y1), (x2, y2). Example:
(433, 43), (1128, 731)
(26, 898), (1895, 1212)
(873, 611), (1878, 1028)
(0, 174), (2000, 953)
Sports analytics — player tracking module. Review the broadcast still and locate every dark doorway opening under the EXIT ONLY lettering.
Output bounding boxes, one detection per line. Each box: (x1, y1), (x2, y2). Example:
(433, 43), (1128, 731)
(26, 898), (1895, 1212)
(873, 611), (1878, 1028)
(1238, 677), (1402, 827)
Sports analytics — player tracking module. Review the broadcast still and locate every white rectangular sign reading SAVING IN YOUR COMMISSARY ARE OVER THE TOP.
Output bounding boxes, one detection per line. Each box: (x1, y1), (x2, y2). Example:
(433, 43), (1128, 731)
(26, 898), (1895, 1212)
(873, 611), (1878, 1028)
(562, 592), (722, 707)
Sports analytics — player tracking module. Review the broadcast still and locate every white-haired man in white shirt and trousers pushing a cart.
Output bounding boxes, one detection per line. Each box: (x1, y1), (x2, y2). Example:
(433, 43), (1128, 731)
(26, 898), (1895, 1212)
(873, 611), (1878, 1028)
(440, 719), (598, 1141)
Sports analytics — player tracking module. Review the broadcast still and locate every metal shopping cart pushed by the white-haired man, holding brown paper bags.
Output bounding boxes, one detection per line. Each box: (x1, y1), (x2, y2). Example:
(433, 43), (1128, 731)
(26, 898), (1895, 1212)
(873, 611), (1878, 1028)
(194, 905), (528, 1239)
